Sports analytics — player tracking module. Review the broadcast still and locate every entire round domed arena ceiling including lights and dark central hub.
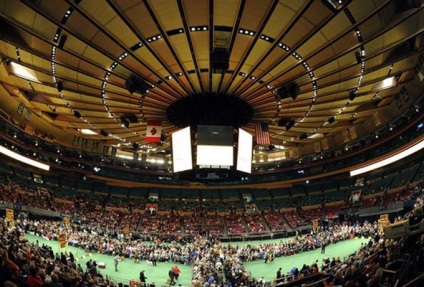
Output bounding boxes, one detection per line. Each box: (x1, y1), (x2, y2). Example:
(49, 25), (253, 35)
(0, 0), (424, 180)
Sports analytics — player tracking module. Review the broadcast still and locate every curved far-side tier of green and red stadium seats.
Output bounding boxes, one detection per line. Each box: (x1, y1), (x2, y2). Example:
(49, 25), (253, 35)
(0, 154), (424, 240)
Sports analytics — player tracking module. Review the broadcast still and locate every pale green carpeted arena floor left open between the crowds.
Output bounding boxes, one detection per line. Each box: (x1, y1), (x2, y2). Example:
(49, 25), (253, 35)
(25, 234), (368, 286)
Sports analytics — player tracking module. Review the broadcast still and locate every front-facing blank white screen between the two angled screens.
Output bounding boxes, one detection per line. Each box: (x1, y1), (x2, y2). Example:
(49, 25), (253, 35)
(196, 145), (234, 166)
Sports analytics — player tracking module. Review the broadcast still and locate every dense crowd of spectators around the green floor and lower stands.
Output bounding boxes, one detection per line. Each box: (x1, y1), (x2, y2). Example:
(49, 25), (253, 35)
(0, 178), (423, 287)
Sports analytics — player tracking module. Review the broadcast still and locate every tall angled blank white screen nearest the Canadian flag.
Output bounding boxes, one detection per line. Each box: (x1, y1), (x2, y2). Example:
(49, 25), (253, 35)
(172, 127), (193, 172)
